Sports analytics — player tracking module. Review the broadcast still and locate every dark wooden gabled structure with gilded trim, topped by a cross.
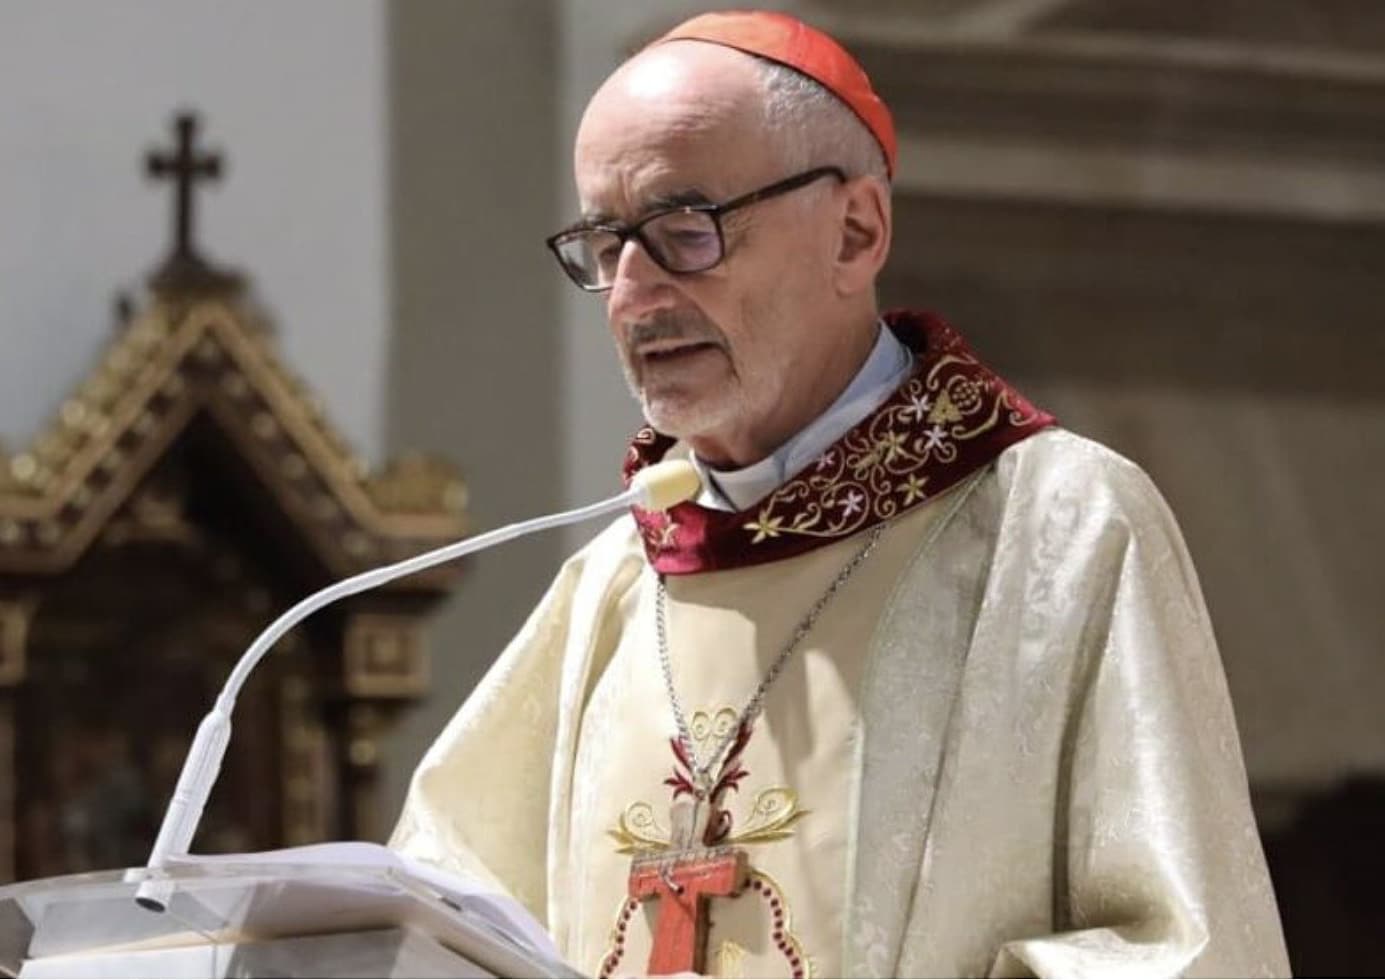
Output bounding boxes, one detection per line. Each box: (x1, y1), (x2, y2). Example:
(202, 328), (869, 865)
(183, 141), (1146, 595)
(0, 112), (465, 880)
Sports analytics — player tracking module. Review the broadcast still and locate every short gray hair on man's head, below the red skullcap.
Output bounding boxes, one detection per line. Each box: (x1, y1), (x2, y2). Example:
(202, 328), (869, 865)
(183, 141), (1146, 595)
(758, 58), (889, 184)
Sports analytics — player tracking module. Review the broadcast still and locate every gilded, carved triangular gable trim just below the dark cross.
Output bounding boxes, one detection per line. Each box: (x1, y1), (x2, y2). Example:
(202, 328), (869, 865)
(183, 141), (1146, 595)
(0, 299), (465, 574)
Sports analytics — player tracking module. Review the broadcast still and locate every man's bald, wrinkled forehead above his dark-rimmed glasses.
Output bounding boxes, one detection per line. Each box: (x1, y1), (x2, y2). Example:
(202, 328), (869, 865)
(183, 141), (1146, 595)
(575, 42), (773, 220)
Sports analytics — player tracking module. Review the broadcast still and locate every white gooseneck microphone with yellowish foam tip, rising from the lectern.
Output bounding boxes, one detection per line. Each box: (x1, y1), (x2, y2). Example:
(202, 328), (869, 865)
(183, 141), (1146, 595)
(134, 460), (701, 912)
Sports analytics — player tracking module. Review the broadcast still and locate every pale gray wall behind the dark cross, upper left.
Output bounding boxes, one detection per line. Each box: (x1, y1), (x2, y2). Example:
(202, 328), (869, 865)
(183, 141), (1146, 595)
(0, 0), (389, 457)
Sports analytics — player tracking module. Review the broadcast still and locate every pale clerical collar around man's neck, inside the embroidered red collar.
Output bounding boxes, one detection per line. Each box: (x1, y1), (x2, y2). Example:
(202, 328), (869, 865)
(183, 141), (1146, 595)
(690, 323), (914, 511)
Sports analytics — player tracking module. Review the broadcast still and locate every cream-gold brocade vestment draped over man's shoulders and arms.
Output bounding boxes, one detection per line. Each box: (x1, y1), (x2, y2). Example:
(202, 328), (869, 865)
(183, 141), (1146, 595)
(392, 430), (1288, 976)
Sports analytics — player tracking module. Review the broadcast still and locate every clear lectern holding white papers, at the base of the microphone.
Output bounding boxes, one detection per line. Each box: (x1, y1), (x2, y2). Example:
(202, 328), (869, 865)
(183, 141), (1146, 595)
(0, 855), (578, 977)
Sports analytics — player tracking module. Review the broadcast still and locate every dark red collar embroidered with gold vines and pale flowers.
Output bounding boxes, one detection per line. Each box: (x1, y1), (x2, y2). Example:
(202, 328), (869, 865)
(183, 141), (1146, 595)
(625, 310), (1054, 574)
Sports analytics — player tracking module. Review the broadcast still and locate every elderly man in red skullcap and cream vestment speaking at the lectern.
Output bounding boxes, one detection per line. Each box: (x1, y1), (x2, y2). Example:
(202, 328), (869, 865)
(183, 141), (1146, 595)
(393, 14), (1287, 976)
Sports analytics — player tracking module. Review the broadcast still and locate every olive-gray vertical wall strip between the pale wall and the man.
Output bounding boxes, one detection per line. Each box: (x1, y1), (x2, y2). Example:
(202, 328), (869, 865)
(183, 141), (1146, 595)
(381, 0), (572, 826)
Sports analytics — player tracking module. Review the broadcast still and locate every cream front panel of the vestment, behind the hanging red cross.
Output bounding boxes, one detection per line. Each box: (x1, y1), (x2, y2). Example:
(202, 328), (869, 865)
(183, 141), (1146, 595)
(569, 500), (947, 977)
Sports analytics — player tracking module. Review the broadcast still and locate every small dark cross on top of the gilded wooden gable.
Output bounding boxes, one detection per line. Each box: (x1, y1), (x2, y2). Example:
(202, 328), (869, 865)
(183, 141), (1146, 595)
(144, 112), (240, 292)
